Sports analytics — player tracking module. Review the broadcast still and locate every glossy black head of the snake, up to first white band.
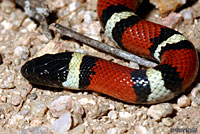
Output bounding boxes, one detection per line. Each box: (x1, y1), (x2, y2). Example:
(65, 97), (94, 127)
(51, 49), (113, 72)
(21, 53), (72, 88)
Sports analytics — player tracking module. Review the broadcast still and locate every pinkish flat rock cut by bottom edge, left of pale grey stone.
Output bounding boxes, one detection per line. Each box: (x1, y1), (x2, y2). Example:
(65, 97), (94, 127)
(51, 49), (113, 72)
(21, 126), (53, 134)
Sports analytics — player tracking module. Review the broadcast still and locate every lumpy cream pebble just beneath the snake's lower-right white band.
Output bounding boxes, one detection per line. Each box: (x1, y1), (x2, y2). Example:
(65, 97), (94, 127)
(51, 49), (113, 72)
(147, 103), (173, 121)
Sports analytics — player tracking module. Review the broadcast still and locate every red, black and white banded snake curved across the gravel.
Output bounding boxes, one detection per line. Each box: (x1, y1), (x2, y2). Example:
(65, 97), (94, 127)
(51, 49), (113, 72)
(21, 0), (199, 104)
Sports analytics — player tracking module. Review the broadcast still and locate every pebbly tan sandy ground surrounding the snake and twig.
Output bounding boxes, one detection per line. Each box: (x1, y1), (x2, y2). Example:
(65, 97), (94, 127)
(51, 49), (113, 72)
(0, 0), (200, 134)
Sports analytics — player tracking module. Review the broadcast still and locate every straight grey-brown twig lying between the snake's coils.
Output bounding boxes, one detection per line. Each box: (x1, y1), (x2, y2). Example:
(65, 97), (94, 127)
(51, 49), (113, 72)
(50, 23), (157, 67)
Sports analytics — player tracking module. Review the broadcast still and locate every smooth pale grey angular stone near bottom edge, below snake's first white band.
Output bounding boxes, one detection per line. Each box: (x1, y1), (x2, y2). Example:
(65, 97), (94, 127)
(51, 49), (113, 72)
(50, 112), (72, 133)
